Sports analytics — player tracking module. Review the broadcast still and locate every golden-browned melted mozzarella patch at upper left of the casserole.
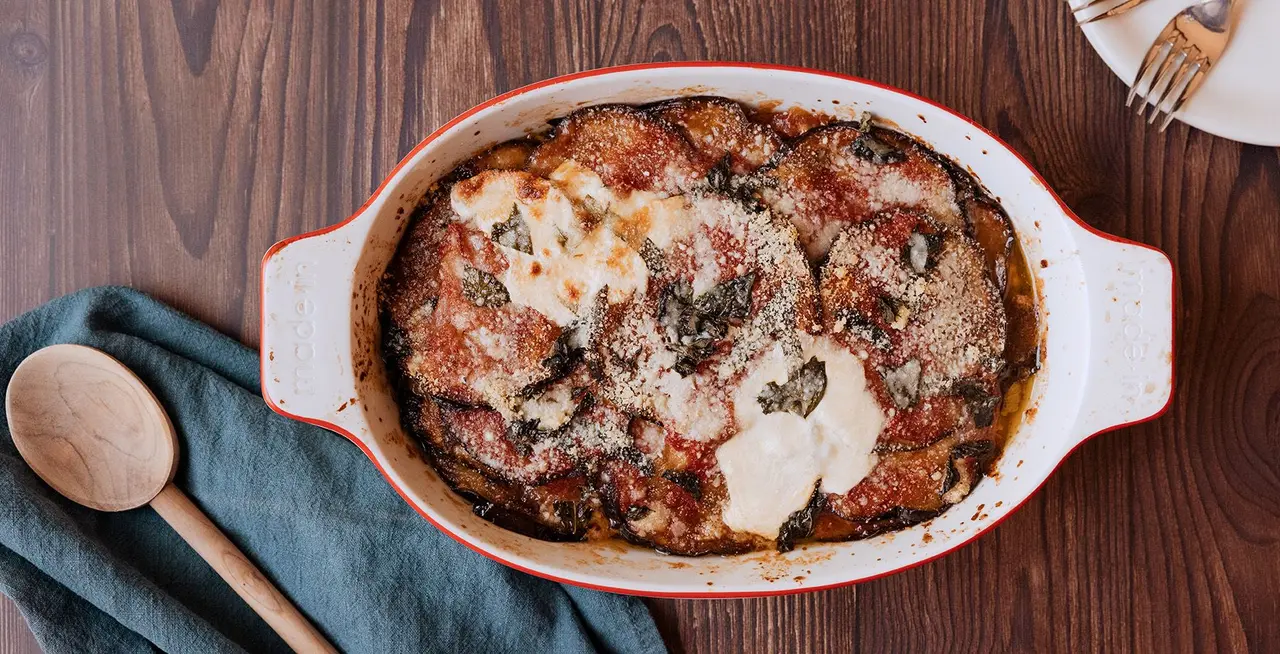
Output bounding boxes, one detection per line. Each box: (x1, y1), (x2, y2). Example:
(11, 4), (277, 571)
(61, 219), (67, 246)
(451, 170), (648, 326)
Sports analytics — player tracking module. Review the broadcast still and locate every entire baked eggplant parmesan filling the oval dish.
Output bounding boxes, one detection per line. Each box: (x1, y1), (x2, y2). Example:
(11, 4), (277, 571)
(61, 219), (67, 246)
(380, 97), (1039, 555)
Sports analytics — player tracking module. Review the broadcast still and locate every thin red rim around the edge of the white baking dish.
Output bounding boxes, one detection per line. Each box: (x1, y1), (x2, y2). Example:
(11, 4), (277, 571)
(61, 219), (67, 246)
(259, 61), (1178, 599)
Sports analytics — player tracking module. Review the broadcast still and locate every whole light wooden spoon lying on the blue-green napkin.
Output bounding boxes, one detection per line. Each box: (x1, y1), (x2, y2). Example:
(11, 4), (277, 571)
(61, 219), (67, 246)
(5, 346), (337, 653)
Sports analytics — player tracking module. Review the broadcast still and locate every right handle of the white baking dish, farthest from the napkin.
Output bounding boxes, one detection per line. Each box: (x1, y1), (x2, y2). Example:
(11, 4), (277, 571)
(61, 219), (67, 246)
(1074, 228), (1174, 439)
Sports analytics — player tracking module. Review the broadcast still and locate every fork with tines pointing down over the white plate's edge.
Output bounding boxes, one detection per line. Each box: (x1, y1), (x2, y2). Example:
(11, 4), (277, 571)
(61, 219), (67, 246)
(1125, 0), (1233, 132)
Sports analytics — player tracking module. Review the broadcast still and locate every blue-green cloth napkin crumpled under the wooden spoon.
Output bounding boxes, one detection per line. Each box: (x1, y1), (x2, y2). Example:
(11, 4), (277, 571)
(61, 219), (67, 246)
(0, 287), (663, 653)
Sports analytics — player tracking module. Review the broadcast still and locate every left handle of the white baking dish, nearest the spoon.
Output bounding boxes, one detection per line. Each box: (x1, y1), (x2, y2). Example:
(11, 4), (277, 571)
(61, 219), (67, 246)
(261, 229), (362, 426)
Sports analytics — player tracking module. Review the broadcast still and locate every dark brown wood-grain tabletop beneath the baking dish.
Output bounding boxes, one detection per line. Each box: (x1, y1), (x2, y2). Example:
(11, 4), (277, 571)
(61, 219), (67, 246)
(0, 0), (1280, 653)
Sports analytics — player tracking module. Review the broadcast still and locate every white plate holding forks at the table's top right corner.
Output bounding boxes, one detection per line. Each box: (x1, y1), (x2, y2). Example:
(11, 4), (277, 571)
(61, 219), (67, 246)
(1084, 0), (1280, 146)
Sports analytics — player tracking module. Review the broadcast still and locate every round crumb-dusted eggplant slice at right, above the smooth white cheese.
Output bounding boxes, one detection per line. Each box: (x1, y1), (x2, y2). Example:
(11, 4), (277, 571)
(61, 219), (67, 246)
(819, 210), (1006, 401)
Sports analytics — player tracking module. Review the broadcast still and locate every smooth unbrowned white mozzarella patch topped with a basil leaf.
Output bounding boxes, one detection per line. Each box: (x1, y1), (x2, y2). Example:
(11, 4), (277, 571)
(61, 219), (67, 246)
(716, 337), (884, 538)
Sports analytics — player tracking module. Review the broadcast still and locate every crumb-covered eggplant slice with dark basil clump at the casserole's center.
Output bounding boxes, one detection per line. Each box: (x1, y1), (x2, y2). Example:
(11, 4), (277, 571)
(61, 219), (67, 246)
(589, 195), (817, 440)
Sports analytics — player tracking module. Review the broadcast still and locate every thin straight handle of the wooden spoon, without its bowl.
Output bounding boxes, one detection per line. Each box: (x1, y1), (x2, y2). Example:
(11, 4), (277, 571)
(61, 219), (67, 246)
(151, 484), (338, 653)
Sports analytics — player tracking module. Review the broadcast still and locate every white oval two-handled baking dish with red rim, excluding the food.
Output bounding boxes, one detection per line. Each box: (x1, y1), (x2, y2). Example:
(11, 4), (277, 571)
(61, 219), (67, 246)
(261, 63), (1174, 598)
